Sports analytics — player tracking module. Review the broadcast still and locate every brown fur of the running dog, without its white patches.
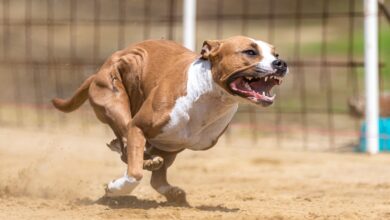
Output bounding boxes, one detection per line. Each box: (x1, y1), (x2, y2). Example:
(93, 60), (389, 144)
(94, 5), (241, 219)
(53, 36), (284, 203)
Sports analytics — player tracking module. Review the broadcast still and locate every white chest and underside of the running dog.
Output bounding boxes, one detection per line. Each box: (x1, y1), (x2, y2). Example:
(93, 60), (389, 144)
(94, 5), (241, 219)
(148, 60), (238, 151)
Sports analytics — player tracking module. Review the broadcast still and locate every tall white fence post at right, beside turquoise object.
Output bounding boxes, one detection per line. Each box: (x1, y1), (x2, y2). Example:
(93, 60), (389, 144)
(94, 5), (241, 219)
(364, 0), (379, 154)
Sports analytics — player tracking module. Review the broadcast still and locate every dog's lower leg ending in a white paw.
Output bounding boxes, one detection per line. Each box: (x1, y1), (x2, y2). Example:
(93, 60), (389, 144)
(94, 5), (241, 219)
(106, 124), (146, 196)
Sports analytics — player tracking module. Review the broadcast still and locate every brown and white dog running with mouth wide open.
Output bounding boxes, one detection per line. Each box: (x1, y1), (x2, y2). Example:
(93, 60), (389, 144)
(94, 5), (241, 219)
(53, 36), (288, 202)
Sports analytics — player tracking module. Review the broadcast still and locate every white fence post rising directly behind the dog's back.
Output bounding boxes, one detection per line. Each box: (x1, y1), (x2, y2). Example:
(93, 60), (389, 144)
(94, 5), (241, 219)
(183, 0), (196, 50)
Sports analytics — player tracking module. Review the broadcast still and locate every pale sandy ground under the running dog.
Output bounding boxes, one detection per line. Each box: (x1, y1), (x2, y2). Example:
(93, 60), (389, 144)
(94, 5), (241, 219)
(0, 128), (390, 220)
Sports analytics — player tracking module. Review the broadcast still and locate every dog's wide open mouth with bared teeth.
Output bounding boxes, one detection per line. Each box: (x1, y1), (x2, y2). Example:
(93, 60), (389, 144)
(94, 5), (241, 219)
(228, 73), (283, 106)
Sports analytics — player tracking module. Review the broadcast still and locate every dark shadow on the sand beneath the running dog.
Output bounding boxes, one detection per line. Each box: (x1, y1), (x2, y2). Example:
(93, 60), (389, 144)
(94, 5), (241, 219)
(73, 196), (240, 212)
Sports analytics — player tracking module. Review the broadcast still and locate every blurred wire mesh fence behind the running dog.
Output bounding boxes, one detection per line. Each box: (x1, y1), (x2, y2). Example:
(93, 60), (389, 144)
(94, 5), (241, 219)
(0, 0), (390, 150)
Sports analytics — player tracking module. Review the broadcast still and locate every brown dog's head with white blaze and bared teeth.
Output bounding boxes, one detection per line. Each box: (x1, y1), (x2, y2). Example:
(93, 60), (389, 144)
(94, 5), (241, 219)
(201, 36), (288, 106)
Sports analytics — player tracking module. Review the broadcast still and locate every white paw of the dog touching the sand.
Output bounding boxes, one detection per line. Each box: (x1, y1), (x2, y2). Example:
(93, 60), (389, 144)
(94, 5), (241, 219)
(106, 173), (140, 197)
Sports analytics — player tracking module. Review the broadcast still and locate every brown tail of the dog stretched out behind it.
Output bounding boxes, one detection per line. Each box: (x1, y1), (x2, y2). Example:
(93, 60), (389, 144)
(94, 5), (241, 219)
(51, 75), (95, 112)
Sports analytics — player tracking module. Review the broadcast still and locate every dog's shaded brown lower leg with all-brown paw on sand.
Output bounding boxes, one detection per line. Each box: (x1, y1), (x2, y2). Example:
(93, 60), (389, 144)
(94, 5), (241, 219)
(150, 148), (187, 204)
